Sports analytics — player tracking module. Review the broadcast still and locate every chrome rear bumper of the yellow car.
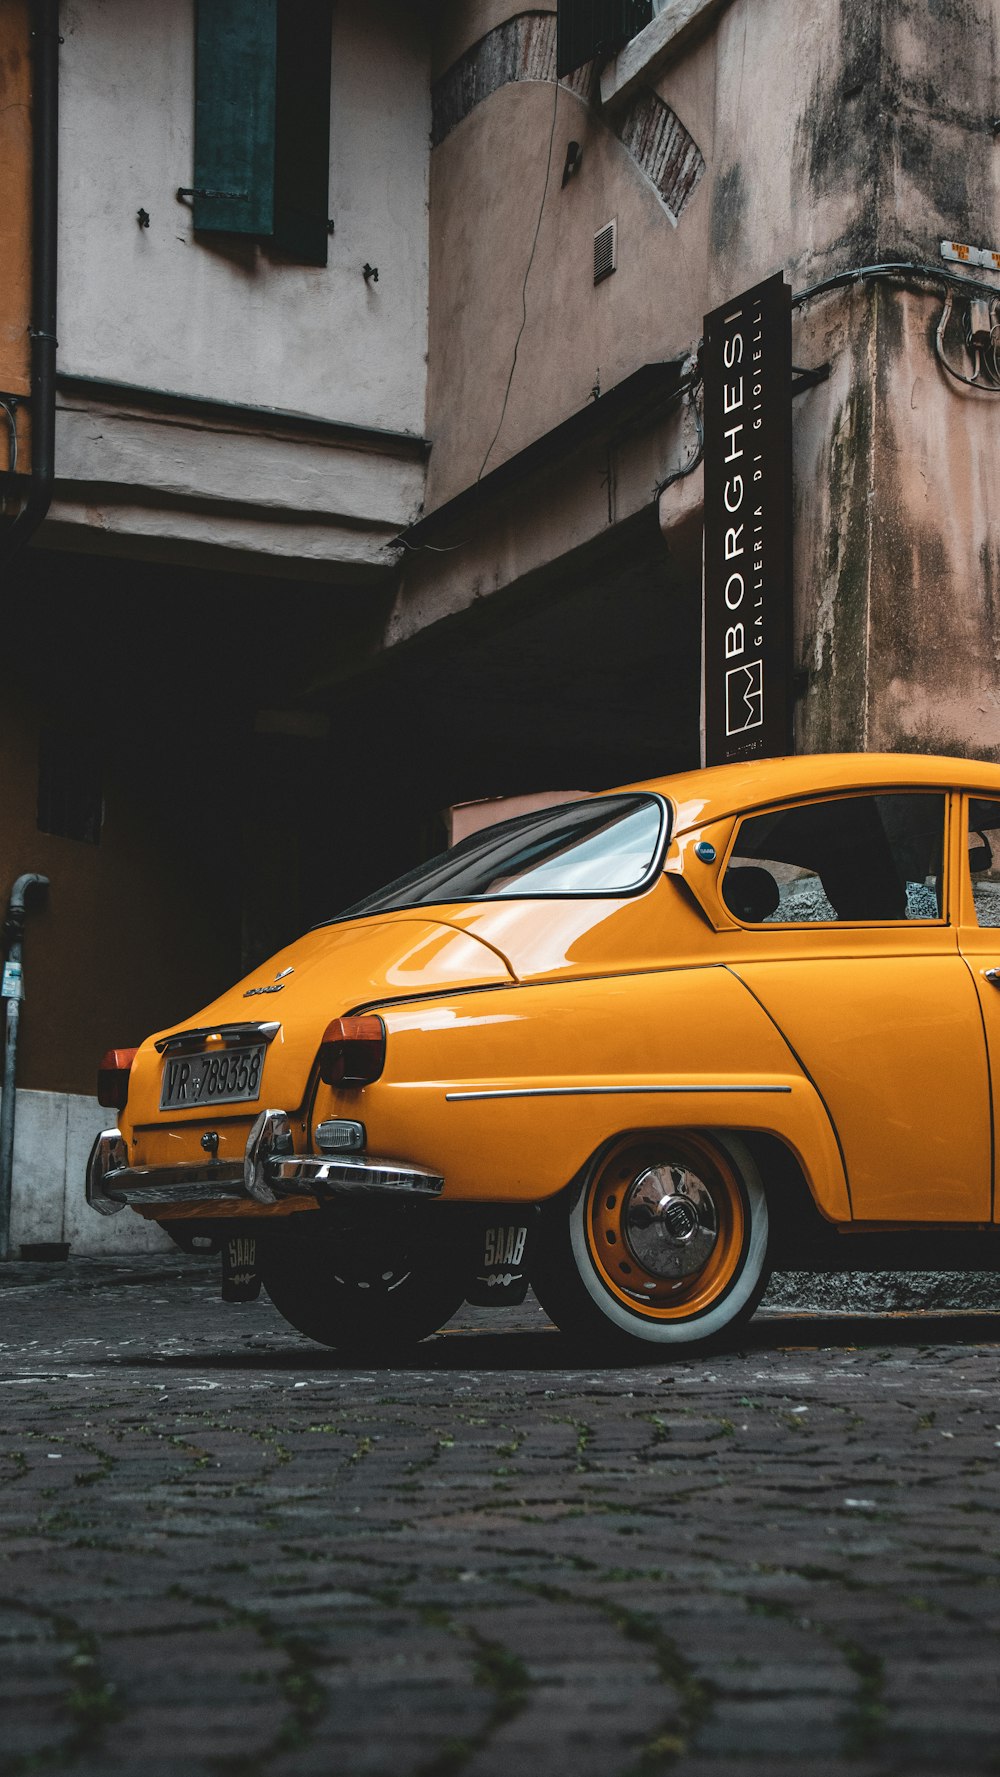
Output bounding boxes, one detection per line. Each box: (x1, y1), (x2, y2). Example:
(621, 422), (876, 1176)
(87, 1111), (444, 1215)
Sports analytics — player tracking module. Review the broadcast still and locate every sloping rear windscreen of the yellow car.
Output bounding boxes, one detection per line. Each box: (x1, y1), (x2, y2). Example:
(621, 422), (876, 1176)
(337, 796), (668, 919)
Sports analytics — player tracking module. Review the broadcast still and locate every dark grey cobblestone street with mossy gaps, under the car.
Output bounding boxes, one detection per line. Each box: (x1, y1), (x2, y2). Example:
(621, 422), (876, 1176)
(0, 1258), (1000, 1777)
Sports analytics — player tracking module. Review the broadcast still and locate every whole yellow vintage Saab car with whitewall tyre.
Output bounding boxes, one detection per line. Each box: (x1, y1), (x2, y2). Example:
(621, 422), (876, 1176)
(87, 753), (1000, 1351)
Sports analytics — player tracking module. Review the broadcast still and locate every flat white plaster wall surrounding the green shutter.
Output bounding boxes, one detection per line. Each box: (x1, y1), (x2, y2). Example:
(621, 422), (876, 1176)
(59, 0), (430, 434)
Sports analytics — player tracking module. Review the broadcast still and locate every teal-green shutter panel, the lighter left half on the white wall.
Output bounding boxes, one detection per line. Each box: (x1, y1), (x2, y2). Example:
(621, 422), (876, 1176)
(194, 0), (277, 236)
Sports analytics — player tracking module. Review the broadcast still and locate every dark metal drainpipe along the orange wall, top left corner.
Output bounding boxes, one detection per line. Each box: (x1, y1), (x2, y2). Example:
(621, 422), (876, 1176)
(0, 0), (59, 567)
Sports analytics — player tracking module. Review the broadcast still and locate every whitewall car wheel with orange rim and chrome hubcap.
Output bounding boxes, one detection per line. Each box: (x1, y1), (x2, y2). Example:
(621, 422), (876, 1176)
(533, 1130), (767, 1347)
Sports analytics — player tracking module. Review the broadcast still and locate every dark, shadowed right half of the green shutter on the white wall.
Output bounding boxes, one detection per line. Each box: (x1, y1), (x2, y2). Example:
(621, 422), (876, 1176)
(274, 0), (332, 265)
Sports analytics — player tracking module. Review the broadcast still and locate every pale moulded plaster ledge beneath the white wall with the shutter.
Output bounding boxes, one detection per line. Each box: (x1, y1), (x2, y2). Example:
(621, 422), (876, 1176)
(44, 382), (426, 585)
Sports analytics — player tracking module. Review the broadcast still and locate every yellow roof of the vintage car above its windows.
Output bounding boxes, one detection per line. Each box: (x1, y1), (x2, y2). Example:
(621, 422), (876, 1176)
(614, 753), (1000, 833)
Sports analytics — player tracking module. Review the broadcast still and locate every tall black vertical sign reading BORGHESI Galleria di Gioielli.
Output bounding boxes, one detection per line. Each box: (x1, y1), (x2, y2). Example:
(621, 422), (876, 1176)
(703, 272), (792, 766)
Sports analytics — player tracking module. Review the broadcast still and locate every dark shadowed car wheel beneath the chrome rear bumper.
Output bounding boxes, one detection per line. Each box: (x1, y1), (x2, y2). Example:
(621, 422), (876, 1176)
(259, 1230), (465, 1356)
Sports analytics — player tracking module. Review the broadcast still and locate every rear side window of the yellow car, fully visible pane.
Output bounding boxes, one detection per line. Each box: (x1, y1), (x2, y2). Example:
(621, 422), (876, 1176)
(723, 793), (944, 926)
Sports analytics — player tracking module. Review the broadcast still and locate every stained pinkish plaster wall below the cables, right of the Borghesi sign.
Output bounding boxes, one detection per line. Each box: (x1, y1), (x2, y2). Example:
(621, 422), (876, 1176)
(794, 271), (1000, 759)
